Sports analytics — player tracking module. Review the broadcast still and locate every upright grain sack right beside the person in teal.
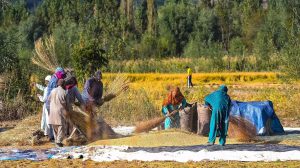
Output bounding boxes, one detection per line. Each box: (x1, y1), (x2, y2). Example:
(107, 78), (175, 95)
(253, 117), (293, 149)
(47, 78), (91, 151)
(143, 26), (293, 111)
(197, 104), (211, 136)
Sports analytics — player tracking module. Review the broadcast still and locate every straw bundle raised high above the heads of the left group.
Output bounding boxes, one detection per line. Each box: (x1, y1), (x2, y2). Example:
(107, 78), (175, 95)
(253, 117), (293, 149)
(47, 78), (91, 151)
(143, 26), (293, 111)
(31, 36), (58, 72)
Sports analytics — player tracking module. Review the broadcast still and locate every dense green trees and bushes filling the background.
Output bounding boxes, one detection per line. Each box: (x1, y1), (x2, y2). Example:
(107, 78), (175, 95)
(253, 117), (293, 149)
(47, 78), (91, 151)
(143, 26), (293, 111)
(0, 0), (300, 76)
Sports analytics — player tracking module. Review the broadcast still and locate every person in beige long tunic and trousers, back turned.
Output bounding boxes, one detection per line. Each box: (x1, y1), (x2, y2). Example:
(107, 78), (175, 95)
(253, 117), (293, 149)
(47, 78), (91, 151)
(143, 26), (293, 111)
(48, 79), (68, 147)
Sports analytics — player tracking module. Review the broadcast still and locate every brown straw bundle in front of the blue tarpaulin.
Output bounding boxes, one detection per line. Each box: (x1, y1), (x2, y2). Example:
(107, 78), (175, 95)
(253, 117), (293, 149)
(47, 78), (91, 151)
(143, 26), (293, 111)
(228, 116), (256, 142)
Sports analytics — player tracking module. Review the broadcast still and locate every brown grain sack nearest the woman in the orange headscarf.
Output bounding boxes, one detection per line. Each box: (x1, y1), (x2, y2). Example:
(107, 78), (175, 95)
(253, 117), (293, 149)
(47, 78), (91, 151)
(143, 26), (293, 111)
(179, 104), (197, 132)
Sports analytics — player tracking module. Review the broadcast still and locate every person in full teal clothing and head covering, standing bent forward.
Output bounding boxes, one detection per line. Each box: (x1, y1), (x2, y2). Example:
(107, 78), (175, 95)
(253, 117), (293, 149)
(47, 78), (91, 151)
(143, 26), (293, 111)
(205, 85), (231, 146)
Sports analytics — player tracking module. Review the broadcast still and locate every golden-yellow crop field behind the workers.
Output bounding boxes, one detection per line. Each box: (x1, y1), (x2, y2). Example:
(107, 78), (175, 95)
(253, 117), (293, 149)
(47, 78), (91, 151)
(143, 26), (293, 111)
(102, 72), (300, 124)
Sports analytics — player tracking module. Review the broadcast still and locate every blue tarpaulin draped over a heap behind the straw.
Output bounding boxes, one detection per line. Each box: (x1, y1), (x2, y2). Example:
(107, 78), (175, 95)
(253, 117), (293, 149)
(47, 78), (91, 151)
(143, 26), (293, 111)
(230, 101), (284, 135)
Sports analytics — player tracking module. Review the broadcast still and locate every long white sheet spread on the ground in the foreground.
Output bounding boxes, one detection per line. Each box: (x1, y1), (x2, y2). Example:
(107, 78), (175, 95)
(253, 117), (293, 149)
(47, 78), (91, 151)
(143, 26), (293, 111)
(0, 129), (300, 162)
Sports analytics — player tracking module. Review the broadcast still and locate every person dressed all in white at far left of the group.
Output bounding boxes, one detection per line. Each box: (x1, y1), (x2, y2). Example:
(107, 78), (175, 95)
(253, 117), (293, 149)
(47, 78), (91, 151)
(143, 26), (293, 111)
(35, 75), (53, 138)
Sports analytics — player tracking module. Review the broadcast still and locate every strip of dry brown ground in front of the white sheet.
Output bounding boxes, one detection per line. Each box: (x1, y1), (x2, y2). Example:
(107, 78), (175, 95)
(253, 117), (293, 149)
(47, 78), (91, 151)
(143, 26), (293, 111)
(0, 159), (300, 168)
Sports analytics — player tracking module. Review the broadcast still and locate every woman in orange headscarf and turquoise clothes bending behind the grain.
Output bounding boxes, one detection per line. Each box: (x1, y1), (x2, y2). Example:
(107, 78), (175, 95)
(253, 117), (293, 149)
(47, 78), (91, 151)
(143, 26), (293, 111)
(162, 87), (187, 129)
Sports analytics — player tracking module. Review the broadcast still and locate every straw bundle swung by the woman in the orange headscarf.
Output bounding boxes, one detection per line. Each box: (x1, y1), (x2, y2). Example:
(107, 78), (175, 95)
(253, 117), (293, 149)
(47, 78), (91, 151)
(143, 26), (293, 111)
(134, 110), (178, 133)
